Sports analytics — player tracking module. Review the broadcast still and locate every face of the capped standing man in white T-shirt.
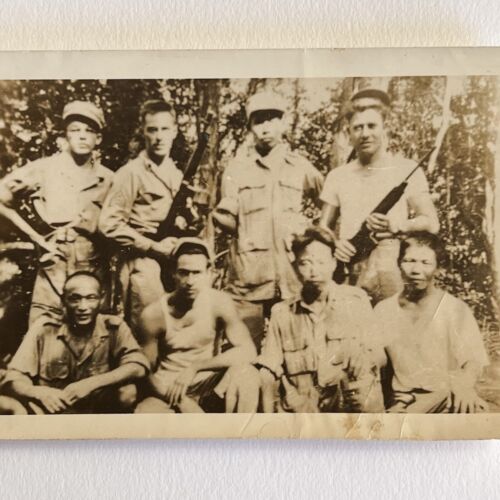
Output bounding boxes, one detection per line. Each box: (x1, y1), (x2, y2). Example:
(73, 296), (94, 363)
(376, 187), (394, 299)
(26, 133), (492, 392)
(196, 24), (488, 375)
(349, 109), (386, 160)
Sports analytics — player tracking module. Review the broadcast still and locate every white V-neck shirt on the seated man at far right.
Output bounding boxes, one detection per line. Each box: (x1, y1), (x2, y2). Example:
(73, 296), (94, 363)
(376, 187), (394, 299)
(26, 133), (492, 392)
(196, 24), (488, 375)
(375, 292), (489, 392)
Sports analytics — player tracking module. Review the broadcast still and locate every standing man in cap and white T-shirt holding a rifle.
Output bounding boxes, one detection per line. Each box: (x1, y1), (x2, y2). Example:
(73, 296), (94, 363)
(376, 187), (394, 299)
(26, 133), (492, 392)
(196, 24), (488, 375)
(320, 89), (439, 303)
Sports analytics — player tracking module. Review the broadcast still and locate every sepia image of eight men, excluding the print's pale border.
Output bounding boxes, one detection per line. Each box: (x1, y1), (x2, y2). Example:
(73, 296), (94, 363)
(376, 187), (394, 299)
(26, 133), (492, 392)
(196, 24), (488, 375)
(0, 66), (500, 430)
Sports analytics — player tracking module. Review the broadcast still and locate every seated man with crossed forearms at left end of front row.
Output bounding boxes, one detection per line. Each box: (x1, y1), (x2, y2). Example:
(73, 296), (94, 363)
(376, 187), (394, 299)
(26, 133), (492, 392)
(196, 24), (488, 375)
(4, 271), (149, 413)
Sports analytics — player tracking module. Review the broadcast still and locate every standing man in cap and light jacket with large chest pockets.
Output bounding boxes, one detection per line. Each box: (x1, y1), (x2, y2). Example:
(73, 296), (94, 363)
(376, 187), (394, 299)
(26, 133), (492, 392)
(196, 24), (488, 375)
(213, 91), (323, 350)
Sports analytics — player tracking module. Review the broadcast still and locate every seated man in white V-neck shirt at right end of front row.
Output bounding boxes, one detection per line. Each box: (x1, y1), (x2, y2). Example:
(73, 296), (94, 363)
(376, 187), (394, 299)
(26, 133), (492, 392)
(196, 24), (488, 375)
(375, 232), (488, 413)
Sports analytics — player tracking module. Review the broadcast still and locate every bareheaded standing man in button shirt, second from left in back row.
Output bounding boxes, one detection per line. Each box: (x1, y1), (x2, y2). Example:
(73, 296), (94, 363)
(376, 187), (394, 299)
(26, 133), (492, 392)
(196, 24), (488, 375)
(99, 100), (182, 332)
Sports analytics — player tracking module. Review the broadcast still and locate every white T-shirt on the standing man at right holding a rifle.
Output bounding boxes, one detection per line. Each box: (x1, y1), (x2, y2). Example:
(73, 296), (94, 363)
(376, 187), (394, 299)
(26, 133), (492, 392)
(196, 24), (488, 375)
(320, 154), (429, 239)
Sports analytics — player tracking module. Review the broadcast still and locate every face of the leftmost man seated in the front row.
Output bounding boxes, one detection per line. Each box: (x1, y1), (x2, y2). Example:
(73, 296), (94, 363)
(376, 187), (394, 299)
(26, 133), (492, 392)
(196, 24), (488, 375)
(63, 275), (101, 328)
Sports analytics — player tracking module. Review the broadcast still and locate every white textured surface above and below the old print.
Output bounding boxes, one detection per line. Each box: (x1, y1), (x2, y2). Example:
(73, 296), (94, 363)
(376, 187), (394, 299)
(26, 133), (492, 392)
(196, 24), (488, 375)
(0, 0), (500, 499)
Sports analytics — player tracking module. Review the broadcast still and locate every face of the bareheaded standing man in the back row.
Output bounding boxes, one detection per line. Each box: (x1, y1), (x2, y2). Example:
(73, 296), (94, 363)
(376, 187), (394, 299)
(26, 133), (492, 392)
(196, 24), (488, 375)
(143, 111), (177, 161)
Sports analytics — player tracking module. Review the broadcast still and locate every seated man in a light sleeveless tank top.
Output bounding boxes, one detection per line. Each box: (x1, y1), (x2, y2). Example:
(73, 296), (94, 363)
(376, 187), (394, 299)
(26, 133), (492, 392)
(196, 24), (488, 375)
(136, 238), (259, 413)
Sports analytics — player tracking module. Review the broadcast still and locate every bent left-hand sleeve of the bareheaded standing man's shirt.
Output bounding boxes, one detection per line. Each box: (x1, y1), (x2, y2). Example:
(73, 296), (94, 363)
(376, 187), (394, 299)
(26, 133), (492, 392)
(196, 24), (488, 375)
(99, 168), (154, 252)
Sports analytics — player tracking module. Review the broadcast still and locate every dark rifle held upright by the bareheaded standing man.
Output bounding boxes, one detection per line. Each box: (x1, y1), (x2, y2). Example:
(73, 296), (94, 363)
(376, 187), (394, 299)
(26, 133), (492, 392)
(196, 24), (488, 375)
(150, 113), (213, 241)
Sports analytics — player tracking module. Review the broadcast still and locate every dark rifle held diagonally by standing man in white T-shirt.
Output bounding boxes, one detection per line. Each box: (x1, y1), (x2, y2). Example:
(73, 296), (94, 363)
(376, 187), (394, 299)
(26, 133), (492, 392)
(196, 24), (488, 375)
(333, 148), (434, 283)
